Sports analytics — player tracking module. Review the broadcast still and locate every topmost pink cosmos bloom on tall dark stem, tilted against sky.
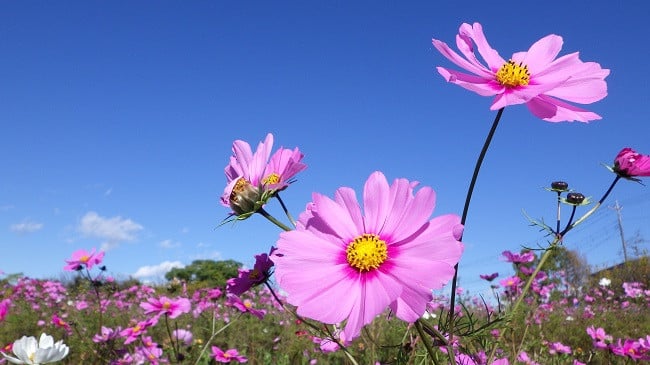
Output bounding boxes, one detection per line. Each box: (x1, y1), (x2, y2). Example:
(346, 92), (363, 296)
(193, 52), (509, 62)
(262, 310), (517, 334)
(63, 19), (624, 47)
(433, 23), (609, 122)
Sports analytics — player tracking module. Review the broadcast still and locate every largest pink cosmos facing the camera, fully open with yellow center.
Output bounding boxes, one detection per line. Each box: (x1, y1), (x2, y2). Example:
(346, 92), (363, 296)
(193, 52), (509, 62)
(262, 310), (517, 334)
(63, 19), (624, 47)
(272, 172), (463, 341)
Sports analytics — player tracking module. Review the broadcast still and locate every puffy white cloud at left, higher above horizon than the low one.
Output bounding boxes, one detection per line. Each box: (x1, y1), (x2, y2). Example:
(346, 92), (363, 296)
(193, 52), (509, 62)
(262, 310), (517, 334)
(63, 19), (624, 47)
(77, 212), (144, 251)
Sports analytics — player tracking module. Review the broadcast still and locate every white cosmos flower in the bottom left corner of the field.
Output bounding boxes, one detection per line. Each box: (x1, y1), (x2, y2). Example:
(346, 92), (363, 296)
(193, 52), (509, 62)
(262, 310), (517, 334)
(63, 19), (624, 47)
(2, 333), (70, 365)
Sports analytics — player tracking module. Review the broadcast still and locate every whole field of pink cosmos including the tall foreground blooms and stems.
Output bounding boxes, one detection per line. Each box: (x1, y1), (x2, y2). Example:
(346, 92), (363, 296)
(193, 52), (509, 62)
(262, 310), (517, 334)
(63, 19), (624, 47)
(0, 17), (650, 365)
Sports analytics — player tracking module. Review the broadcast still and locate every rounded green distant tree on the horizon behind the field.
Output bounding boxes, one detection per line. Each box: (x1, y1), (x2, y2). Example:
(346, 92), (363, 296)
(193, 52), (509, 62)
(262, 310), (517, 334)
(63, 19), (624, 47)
(165, 260), (242, 287)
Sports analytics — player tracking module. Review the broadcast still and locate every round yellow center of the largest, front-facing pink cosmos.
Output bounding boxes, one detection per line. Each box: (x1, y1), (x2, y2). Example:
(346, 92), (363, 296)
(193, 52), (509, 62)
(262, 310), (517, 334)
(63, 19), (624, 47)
(345, 233), (388, 272)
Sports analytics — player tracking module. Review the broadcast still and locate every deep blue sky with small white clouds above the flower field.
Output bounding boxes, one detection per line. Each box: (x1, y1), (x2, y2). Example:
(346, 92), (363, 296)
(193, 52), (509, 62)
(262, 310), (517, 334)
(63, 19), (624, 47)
(0, 1), (650, 292)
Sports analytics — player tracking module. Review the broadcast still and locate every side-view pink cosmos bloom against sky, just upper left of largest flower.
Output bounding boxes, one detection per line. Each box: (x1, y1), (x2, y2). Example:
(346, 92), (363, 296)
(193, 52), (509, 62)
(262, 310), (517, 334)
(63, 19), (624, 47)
(221, 133), (307, 215)
